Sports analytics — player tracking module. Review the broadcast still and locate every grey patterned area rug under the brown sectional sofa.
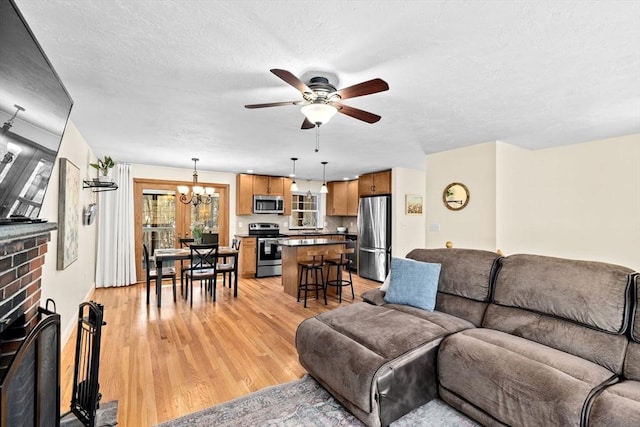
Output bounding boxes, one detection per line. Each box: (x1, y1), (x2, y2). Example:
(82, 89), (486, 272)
(157, 375), (479, 427)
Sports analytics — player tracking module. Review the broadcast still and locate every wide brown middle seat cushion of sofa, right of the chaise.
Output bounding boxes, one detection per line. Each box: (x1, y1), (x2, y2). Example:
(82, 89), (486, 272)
(438, 328), (616, 426)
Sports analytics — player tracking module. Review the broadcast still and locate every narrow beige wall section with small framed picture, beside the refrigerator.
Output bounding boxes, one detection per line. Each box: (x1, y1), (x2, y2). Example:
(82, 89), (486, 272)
(391, 168), (426, 257)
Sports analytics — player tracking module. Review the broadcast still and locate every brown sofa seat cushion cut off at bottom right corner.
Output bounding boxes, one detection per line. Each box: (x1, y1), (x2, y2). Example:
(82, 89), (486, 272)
(588, 381), (640, 427)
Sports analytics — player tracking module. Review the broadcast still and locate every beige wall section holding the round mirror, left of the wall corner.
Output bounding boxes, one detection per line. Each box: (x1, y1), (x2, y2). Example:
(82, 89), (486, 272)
(426, 142), (496, 250)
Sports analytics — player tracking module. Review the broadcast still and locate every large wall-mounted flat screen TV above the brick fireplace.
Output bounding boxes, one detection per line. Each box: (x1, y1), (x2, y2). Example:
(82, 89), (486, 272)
(0, 0), (73, 223)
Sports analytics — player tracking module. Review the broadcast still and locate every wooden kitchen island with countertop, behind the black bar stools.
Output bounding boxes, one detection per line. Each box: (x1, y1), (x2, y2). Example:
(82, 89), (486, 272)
(280, 238), (346, 298)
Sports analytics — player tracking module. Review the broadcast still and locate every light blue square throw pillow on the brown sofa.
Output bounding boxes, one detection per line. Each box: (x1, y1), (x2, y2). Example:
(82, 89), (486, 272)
(384, 258), (441, 311)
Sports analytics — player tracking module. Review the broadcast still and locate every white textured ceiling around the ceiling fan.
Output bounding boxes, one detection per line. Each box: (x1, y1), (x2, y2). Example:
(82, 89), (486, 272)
(10, 0), (640, 179)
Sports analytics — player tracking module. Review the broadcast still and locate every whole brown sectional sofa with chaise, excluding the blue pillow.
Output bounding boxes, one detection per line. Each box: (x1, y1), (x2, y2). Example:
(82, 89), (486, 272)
(296, 249), (640, 426)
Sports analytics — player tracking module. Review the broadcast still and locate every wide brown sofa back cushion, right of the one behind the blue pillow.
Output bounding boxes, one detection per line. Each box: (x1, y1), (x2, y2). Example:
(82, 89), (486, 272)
(494, 255), (633, 334)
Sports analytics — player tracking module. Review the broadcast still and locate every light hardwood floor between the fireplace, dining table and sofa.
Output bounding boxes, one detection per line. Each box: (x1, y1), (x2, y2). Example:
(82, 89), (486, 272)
(61, 275), (380, 427)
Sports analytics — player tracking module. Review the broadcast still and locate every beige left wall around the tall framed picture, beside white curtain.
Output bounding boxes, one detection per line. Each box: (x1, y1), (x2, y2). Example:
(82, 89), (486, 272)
(40, 120), (100, 343)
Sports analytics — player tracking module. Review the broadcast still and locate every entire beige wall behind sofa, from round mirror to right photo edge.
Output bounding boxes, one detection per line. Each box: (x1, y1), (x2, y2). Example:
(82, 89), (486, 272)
(426, 134), (640, 270)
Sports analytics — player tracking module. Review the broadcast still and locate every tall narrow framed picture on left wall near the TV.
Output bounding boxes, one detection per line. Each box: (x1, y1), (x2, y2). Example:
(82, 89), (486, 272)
(57, 158), (80, 270)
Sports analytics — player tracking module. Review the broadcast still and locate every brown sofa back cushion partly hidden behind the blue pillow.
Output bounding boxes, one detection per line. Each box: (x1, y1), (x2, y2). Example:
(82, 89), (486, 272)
(407, 248), (500, 301)
